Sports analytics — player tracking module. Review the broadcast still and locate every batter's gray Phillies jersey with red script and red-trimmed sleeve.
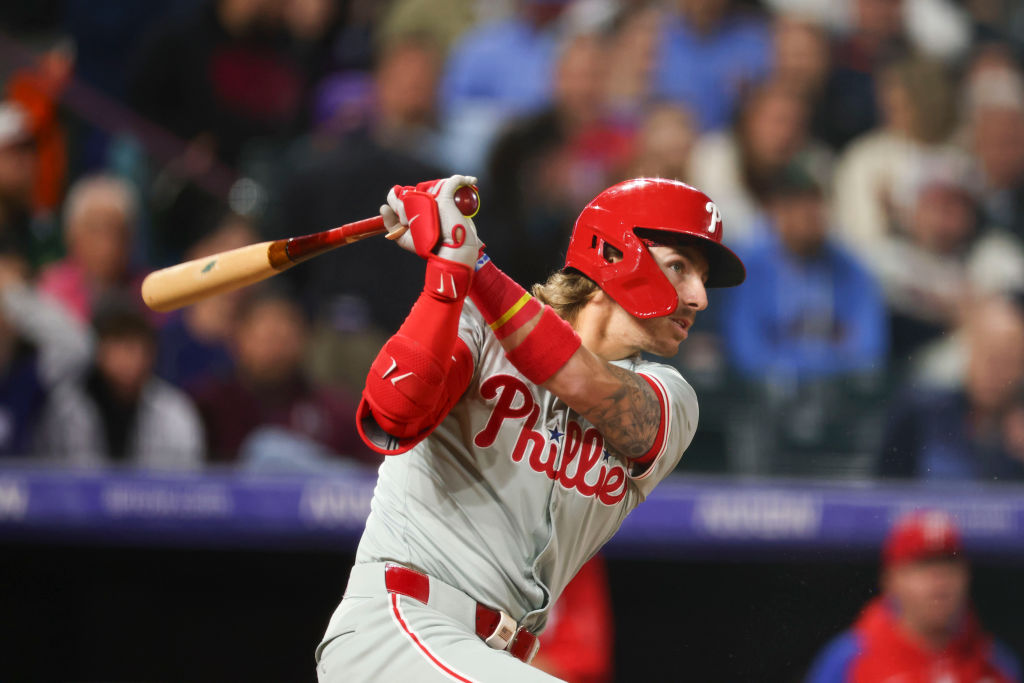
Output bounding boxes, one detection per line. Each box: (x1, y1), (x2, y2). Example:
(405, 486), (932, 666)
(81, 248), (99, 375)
(322, 301), (697, 679)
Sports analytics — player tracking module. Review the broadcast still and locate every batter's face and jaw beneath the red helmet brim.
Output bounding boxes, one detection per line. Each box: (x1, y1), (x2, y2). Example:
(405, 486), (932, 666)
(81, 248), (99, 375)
(634, 247), (709, 357)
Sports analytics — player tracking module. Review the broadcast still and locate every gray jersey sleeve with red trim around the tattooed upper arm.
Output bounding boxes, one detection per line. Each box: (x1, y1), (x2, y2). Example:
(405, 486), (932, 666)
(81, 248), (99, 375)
(630, 362), (698, 496)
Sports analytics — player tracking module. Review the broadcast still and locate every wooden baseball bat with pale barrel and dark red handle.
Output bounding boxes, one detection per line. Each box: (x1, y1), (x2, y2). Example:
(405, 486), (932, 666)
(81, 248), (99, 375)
(142, 185), (480, 312)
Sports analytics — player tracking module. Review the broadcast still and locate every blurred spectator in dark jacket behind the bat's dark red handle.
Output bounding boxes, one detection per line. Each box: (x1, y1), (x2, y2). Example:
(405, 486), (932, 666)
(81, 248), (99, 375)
(272, 35), (446, 335)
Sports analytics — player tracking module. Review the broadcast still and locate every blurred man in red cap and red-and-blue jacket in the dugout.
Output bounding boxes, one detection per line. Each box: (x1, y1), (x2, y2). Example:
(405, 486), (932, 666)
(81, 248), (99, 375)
(807, 511), (1021, 683)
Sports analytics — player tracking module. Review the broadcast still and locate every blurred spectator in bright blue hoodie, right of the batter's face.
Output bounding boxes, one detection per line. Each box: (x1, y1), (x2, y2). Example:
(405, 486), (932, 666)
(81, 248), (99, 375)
(720, 166), (889, 476)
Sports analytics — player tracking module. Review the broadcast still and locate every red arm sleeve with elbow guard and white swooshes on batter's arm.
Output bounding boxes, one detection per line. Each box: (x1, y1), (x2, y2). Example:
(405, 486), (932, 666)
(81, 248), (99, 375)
(356, 260), (473, 455)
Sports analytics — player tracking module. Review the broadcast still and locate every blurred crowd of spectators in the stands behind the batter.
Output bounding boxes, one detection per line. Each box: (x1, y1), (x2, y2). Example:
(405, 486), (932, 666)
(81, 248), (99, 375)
(0, 0), (1024, 480)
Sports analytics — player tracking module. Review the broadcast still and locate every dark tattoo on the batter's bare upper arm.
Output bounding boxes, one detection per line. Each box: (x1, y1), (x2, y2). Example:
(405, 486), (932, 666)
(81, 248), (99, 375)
(582, 366), (662, 458)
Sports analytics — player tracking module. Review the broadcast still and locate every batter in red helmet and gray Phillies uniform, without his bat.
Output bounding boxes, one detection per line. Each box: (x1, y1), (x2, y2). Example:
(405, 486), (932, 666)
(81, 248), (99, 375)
(315, 175), (745, 683)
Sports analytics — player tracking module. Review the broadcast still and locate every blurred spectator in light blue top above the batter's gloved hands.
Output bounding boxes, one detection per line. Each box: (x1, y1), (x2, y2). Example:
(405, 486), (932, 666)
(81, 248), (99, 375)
(438, 0), (568, 176)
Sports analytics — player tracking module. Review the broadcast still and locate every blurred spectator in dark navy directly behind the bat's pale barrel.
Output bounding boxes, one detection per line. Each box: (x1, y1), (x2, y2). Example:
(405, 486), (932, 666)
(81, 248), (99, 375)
(157, 214), (257, 390)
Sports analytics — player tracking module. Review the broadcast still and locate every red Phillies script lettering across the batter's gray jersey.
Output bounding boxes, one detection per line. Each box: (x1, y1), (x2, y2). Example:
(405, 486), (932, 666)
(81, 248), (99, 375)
(473, 375), (626, 505)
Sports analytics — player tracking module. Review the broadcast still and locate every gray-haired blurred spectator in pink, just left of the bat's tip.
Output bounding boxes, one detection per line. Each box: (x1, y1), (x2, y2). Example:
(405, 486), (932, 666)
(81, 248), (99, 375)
(39, 175), (143, 323)
